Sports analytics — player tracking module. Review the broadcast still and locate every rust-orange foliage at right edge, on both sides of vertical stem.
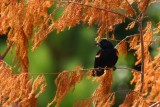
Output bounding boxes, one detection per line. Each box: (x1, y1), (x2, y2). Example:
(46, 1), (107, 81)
(127, 22), (160, 107)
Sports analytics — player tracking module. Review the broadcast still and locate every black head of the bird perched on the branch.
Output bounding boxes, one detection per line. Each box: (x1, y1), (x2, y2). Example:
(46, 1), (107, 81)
(96, 39), (114, 49)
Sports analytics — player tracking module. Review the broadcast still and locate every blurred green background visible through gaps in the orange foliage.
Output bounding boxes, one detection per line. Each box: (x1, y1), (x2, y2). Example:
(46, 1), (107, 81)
(0, 1), (160, 107)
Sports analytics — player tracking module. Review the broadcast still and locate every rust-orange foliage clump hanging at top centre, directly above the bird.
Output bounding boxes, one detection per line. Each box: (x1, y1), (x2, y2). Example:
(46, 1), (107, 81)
(56, 0), (134, 37)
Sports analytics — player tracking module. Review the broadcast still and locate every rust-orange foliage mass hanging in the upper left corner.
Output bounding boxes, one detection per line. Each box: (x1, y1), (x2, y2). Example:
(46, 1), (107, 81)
(0, 0), (53, 72)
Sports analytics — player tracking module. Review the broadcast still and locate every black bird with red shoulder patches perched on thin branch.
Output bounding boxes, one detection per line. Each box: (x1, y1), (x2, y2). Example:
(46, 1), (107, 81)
(92, 39), (118, 76)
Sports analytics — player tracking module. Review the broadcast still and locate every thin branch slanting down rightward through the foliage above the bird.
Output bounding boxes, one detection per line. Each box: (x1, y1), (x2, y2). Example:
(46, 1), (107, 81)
(62, 1), (135, 21)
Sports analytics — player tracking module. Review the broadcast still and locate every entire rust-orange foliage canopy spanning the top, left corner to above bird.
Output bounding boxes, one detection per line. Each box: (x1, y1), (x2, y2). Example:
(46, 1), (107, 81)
(0, 0), (147, 72)
